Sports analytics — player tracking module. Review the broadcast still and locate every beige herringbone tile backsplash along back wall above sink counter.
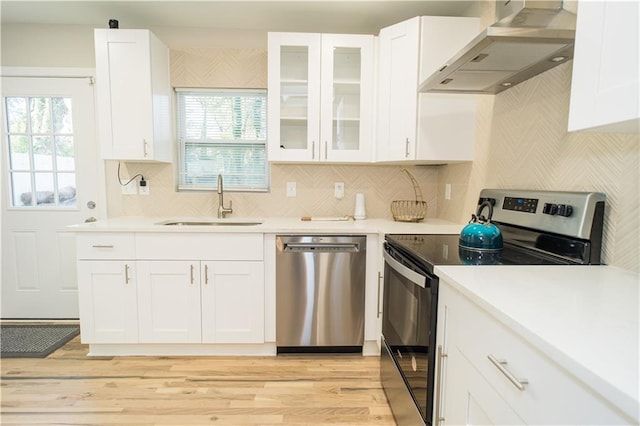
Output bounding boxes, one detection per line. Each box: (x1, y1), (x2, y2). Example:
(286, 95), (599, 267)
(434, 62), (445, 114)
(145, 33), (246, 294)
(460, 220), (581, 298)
(107, 161), (440, 219)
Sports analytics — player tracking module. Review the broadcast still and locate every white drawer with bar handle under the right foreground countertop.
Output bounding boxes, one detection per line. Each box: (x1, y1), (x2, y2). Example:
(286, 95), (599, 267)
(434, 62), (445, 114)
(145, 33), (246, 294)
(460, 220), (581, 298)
(449, 292), (629, 424)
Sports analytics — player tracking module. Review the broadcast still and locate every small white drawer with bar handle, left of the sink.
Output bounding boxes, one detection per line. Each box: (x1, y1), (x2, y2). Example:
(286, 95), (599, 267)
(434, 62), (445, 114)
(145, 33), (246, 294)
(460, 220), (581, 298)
(76, 233), (136, 259)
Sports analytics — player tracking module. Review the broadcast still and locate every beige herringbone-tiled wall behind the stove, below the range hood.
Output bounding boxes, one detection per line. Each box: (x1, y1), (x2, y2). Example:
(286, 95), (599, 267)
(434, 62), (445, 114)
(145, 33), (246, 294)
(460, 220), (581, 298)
(438, 62), (640, 271)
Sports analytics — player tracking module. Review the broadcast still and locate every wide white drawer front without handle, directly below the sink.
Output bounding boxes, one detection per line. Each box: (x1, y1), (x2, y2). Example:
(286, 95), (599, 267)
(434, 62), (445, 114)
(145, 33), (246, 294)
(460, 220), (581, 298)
(136, 233), (264, 260)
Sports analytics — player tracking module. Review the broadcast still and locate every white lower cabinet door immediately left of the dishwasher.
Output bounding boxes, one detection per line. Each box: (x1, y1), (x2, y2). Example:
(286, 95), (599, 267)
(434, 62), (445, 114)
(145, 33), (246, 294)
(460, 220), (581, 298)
(201, 261), (265, 343)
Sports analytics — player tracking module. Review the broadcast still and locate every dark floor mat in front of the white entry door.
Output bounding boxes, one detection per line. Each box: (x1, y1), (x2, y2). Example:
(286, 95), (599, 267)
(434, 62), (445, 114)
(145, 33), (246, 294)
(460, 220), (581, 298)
(0, 325), (80, 358)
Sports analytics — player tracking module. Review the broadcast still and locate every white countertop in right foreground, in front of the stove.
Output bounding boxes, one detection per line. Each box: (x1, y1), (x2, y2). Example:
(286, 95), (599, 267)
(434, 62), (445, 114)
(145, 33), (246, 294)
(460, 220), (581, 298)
(435, 266), (640, 422)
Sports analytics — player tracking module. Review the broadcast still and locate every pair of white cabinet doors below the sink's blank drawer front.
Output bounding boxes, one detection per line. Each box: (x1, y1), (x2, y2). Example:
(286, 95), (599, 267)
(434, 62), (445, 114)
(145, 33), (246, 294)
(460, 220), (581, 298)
(137, 260), (264, 343)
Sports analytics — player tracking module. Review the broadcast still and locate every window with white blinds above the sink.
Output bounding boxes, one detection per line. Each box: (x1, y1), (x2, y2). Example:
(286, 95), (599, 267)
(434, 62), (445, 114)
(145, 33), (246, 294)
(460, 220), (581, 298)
(176, 89), (269, 191)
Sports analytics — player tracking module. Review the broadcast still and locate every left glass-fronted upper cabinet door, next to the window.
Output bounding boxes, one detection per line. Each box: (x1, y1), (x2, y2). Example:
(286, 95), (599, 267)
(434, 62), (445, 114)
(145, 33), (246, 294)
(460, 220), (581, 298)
(268, 33), (320, 162)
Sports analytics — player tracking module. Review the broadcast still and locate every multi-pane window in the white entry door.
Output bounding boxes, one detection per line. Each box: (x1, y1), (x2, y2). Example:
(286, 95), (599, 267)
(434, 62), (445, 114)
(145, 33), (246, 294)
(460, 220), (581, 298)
(5, 96), (77, 208)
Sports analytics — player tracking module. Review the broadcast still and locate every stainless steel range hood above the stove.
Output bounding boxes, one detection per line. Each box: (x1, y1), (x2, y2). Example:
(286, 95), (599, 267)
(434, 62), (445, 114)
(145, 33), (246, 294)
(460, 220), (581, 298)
(418, 0), (576, 94)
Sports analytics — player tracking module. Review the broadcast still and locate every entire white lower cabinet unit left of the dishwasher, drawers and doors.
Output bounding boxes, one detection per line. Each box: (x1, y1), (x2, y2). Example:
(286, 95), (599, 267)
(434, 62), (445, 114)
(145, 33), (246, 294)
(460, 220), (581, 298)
(76, 234), (265, 345)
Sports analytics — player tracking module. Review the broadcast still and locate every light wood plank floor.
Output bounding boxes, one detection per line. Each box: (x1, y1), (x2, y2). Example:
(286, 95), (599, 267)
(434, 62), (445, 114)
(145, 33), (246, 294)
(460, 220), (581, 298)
(0, 337), (395, 426)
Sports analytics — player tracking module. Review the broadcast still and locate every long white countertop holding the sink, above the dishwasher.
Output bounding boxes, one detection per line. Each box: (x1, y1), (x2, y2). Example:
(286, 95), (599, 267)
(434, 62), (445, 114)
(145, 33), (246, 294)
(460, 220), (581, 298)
(67, 217), (464, 234)
